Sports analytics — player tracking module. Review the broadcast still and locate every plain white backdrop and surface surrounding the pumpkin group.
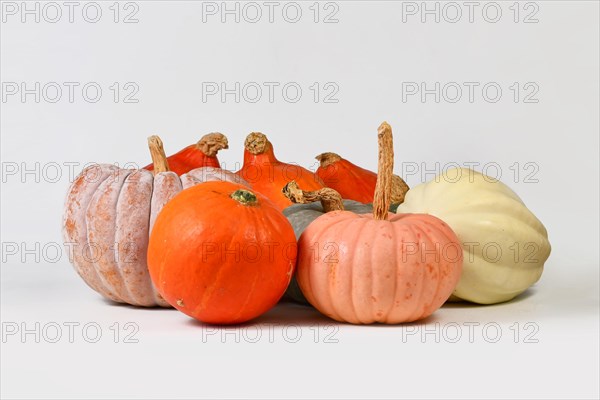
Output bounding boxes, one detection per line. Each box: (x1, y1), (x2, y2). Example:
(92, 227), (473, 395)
(0, 1), (600, 398)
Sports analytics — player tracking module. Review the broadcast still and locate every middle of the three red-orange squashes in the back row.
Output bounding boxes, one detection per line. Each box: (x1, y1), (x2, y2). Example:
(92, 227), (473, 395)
(237, 132), (325, 210)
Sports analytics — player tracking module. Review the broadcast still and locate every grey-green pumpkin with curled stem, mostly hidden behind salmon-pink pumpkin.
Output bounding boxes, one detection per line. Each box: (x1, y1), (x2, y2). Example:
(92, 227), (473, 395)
(282, 181), (373, 305)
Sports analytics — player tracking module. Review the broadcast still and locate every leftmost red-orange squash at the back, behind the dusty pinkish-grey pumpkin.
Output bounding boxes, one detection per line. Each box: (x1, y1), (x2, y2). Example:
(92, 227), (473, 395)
(144, 132), (229, 175)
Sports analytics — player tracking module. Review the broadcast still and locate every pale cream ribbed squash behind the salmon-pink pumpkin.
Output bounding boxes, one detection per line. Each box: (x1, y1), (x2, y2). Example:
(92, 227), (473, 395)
(396, 168), (550, 304)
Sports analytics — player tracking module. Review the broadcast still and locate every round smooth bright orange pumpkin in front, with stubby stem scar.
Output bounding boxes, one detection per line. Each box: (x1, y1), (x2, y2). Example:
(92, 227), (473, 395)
(148, 182), (296, 324)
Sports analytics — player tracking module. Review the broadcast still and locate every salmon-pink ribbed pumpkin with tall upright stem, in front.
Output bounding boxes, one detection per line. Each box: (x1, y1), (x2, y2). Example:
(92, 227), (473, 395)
(296, 122), (462, 324)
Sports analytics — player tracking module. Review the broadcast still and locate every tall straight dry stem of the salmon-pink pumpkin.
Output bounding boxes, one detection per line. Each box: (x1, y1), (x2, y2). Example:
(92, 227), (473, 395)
(373, 121), (394, 220)
